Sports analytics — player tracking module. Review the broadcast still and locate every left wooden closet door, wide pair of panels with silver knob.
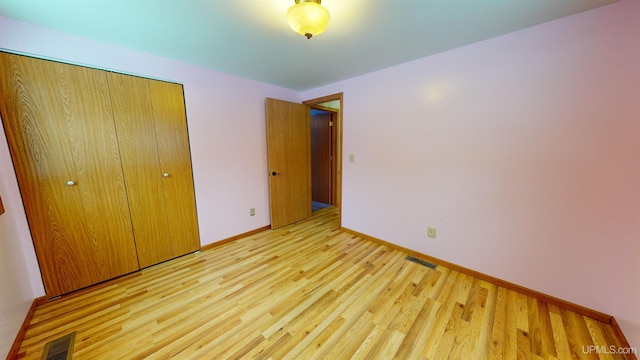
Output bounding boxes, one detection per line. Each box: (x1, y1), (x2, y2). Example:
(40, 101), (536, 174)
(0, 53), (138, 297)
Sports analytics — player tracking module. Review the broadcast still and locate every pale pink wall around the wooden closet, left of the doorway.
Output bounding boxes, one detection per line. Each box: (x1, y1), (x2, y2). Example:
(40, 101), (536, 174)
(0, 17), (300, 354)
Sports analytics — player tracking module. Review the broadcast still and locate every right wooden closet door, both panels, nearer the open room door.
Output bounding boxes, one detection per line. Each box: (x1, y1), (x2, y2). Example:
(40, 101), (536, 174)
(109, 73), (200, 267)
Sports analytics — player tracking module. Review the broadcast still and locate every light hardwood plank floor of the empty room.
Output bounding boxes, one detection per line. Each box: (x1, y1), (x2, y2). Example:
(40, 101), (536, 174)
(13, 208), (625, 359)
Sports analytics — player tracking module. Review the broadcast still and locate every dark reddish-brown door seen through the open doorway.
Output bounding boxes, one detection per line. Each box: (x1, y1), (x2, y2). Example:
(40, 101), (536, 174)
(311, 110), (333, 205)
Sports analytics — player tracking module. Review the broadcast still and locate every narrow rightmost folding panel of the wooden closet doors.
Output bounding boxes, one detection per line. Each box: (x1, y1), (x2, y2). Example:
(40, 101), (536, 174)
(149, 80), (200, 256)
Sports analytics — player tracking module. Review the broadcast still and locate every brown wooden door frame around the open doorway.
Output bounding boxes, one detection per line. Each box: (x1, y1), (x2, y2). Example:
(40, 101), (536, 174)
(302, 92), (344, 228)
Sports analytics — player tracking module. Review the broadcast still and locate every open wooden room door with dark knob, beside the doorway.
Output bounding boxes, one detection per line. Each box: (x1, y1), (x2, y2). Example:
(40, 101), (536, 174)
(266, 99), (311, 229)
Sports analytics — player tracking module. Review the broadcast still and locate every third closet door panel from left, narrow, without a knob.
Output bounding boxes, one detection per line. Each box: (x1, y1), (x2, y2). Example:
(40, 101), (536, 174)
(107, 73), (175, 268)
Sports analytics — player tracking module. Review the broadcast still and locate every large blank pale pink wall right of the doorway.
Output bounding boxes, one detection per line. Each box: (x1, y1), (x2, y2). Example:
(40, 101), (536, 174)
(303, 0), (640, 346)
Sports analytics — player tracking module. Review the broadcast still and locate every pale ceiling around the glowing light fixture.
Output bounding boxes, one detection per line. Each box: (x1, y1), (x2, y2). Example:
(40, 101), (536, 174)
(0, 0), (617, 90)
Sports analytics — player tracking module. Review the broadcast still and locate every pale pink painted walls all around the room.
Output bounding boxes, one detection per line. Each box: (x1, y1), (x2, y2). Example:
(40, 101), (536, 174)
(0, 0), (640, 353)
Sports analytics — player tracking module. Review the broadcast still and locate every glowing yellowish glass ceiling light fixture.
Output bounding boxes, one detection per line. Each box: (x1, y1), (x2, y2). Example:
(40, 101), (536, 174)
(287, 0), (330, 39)
